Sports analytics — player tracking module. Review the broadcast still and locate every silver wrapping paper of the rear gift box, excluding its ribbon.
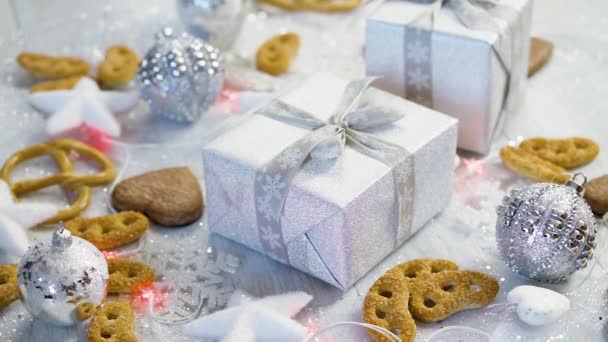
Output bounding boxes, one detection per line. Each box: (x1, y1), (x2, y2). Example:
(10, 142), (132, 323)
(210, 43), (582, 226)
(366, 0), (532, 153)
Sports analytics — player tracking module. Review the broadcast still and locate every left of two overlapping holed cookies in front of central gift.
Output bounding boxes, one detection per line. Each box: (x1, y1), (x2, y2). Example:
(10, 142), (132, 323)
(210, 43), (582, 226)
(363, 268), (416, 342)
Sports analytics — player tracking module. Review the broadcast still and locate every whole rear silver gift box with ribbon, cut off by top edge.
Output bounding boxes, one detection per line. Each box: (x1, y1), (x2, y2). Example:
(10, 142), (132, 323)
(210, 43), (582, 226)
(366, 0), (532, 154)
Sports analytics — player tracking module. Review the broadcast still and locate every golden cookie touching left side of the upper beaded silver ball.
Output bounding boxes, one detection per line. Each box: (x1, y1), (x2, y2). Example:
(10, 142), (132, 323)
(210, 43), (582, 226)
(97, 45), (139, 88)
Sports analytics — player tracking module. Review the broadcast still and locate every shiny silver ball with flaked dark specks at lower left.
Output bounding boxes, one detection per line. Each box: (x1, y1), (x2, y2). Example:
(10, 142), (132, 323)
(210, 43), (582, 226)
(18, 226), (108, 326)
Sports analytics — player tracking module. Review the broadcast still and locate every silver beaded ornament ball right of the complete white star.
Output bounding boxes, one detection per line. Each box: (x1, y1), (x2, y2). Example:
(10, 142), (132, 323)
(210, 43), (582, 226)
(135, 28), (224, 122)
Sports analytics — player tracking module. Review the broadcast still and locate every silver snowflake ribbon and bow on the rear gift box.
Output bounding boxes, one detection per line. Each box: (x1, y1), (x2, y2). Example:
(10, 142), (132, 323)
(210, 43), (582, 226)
(403, 0), (521, 113)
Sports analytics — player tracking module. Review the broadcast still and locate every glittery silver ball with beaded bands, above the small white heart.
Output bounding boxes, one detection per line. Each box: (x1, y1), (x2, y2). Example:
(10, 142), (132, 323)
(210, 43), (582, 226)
(496, 177), (596, 282)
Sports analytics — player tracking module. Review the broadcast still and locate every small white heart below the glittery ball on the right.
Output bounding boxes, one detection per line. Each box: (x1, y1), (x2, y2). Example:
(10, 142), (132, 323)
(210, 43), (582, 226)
(507, 285), (570, 325)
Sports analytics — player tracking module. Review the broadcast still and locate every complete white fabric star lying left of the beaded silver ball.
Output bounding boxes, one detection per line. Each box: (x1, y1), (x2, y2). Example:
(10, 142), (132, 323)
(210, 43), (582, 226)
(29, 77), (139, 137)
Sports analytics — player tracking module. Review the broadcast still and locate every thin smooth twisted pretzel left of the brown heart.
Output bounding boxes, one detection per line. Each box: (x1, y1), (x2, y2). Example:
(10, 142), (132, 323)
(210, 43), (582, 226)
(0, 139), (116, 224)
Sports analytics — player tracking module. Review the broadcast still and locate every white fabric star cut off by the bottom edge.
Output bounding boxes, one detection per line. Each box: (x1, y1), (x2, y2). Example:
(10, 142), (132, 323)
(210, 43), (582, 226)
(183, 292), (312, 342)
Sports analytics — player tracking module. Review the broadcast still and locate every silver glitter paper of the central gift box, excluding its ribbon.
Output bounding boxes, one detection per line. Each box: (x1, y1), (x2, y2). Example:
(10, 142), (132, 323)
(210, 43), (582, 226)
(203, 73), (457, 289)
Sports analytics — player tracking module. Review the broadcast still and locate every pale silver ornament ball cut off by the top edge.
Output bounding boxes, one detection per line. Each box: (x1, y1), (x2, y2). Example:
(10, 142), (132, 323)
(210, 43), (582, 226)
(177, 0), (247, 49)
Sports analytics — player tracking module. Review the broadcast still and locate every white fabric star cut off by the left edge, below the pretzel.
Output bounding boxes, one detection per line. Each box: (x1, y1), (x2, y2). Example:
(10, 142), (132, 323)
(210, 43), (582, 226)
(0, 180), (58, 257)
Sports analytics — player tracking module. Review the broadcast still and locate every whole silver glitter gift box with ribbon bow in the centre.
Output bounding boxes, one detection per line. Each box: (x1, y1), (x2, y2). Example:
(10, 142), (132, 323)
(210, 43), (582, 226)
(203, 73), (457, 289)
